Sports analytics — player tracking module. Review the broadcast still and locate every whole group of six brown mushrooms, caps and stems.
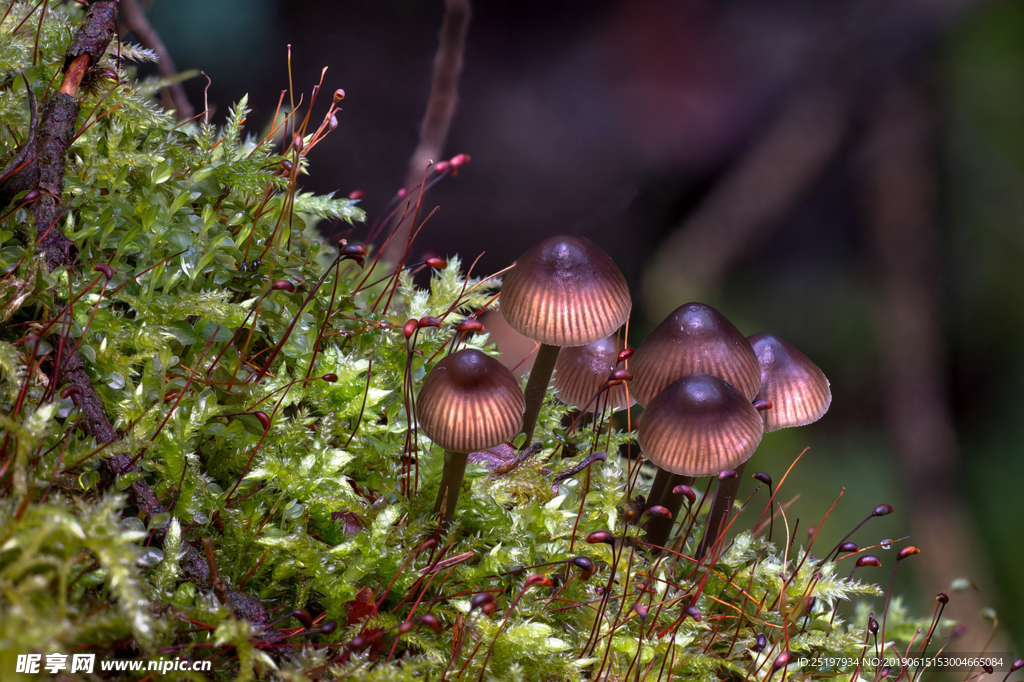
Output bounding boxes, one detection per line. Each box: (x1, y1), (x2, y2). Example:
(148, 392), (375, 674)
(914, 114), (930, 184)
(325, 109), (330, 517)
(417, 236), (831, 556)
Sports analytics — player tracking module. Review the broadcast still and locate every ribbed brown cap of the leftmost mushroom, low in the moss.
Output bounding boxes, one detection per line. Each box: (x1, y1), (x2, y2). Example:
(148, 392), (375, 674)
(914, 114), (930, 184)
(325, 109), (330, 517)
(416, 348), (524, 453)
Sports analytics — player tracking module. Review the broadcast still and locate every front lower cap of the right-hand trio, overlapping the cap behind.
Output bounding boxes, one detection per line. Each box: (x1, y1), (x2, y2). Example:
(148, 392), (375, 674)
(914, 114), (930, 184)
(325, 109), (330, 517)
(637, 374), (763, 476)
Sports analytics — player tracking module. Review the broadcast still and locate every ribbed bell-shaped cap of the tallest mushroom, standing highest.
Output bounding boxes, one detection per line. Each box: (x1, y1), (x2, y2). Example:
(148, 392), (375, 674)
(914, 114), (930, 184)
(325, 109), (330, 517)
(501, 235), (632, 346)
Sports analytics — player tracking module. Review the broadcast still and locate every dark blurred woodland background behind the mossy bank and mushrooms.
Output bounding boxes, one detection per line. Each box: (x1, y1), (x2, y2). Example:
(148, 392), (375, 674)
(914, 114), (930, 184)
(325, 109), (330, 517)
(142, 0), (1024, 655)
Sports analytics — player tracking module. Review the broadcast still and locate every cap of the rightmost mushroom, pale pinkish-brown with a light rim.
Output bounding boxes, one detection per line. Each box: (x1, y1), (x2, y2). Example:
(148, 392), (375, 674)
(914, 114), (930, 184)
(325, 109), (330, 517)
(749, 334), (831, 432)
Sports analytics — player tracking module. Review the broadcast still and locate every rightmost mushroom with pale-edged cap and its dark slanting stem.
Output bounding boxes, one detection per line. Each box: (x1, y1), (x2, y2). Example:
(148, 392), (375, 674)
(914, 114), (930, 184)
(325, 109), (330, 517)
(696, 334), (831, 558)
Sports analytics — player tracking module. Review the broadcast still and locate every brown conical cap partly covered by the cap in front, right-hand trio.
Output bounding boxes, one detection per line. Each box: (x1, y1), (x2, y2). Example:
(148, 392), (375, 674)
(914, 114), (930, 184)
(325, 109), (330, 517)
(630, 303), (761, 404)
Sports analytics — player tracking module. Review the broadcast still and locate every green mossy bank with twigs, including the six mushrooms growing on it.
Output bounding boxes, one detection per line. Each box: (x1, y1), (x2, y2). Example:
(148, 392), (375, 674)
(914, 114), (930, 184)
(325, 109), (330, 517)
(0, 0), (1003, 680)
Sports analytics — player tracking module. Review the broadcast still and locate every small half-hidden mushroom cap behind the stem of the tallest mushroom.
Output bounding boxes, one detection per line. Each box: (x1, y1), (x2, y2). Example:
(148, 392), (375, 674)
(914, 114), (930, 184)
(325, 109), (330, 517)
(555, 336), (636, 412)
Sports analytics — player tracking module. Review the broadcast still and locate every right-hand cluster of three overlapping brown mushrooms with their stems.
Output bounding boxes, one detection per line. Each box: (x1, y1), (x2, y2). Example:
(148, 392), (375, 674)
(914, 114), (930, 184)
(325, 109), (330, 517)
(632, 303), (831, 558)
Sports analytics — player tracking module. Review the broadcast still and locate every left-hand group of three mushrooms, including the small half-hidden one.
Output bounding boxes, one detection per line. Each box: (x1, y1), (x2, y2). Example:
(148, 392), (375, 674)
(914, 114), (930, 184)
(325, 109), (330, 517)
(416, 236), (632, 525)
